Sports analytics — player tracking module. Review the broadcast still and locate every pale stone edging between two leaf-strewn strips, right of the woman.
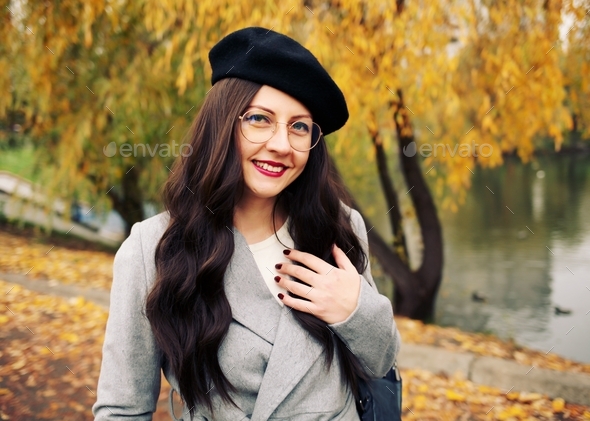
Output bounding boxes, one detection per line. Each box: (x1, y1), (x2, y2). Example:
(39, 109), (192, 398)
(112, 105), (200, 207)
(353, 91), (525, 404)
(398, 344), (590, 406)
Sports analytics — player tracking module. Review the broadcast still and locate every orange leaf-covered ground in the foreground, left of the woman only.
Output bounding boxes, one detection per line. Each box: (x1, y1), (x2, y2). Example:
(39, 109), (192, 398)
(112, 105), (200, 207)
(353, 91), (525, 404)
(0, 280), (170, 421)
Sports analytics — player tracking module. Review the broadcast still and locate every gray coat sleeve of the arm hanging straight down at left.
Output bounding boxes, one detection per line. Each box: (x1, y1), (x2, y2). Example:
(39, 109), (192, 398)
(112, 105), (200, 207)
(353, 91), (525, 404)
(92, 223), (162, 420)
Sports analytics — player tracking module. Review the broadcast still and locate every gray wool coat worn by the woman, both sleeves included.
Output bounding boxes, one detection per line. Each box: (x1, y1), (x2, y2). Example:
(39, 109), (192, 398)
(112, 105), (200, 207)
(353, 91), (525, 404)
(92, 207), (400, 421)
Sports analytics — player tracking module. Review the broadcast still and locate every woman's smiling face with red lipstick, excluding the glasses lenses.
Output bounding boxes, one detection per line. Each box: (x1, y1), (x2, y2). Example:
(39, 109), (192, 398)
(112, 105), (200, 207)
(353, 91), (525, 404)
(238, 85), (311, 205)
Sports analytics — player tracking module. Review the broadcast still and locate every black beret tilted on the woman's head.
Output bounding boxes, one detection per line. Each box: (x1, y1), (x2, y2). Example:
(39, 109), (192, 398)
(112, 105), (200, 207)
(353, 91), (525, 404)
(209, 27), (348, 135)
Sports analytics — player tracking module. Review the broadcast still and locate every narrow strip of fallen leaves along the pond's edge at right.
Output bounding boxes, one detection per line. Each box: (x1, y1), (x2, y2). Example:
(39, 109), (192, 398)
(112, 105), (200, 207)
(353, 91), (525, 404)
(395, 317), (590, 374)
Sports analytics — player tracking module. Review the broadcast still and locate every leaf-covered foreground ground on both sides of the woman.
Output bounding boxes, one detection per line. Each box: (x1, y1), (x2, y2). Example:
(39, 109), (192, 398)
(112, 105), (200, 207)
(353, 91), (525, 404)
(0, 280), (590, 421)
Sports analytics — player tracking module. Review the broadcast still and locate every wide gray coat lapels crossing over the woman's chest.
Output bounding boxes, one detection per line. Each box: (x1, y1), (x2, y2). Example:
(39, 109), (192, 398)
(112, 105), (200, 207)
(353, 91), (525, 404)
(225, 227), (324, 421)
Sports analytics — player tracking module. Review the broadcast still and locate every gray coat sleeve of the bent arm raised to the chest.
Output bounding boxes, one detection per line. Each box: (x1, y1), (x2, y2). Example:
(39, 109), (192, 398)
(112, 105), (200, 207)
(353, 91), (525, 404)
(328, 209), (401, 377)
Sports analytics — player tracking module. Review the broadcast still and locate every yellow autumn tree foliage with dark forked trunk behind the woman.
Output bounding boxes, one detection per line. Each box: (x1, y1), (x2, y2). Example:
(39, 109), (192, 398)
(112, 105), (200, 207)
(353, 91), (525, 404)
(0, 0), (590, 319)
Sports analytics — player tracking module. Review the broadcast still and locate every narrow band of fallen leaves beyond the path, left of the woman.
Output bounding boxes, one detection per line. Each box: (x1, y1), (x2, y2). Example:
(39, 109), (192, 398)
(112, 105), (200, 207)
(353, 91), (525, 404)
(0, 226), (114, 290)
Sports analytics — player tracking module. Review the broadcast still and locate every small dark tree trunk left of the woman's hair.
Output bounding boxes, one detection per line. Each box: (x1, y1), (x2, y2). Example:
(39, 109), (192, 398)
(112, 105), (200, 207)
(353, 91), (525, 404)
(107, 166), (145, 237)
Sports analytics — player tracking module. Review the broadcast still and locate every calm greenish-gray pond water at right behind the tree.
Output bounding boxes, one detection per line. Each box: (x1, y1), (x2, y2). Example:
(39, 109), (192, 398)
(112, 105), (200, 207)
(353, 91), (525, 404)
(436, 155), (590, 363)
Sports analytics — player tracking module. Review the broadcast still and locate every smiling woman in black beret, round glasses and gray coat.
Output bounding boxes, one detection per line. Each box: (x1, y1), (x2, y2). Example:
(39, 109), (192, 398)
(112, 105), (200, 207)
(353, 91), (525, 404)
(93, 28), (399, 421)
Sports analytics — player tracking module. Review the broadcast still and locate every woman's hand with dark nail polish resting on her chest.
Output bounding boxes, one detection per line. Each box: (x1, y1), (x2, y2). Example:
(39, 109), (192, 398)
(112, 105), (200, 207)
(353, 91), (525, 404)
(275, 245), (361, 324)
